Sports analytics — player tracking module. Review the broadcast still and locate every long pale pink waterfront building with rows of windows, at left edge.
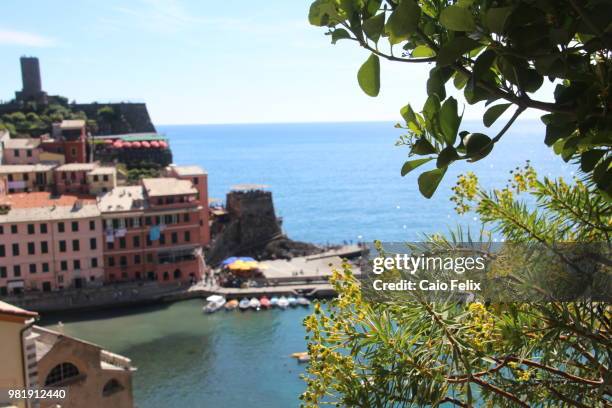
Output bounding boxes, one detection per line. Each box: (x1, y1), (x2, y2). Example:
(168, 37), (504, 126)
(0, 192), (104, 296)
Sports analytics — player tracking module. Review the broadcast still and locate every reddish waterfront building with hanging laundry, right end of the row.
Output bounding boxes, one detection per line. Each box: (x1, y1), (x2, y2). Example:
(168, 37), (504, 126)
(98, 168), (210, 282)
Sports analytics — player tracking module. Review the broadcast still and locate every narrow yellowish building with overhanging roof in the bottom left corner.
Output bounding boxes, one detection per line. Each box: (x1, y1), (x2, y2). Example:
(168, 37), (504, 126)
(0, 301), (38, 408)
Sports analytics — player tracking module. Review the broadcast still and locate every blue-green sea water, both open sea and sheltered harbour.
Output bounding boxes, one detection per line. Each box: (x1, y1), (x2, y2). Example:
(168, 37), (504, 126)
(43, 120), (577, 408)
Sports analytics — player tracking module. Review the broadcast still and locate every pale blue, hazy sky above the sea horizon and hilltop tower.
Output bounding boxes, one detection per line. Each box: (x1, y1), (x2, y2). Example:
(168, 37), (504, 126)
(0, 0), (556, 125)
